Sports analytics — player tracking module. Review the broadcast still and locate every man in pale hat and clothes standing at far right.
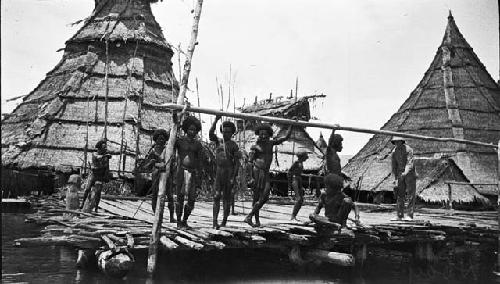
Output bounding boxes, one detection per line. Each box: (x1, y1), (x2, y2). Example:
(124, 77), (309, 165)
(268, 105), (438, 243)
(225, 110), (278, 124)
(391, 136), (417, 221)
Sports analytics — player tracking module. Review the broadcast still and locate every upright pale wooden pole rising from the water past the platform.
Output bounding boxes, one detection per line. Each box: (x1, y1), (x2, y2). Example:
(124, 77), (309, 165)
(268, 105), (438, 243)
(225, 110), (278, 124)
(147, 0), (203, 274)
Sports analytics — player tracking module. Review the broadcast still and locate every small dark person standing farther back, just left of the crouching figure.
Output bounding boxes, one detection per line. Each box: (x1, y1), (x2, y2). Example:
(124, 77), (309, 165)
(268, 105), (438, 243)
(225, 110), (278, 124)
(288, 151), (309, 221)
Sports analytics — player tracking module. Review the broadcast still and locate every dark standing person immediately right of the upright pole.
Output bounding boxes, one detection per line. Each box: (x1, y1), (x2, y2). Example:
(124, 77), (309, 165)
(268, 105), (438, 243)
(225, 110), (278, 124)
(175, 116), (203, 228)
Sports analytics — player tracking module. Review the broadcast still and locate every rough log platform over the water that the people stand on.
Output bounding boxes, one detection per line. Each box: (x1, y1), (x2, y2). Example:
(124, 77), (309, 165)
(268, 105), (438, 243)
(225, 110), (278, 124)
(15, 196), (499, 266)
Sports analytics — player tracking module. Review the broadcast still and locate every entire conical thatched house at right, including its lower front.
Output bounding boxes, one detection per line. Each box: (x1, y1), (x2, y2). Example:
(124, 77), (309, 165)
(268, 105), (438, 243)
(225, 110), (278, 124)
(343, 12), (500, 207)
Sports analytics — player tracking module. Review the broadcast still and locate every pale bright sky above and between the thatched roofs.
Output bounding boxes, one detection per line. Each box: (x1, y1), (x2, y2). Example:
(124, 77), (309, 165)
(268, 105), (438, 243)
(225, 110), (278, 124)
(1, 0), (499, 154)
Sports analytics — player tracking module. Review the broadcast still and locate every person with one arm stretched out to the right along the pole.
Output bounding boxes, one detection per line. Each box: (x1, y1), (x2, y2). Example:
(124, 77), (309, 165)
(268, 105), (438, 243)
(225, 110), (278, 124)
(244, 123), (292, 227)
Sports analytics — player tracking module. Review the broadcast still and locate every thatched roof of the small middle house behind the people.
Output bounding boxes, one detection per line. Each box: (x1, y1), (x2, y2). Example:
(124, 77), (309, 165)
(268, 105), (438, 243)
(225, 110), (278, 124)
(235, 97), (323, 172)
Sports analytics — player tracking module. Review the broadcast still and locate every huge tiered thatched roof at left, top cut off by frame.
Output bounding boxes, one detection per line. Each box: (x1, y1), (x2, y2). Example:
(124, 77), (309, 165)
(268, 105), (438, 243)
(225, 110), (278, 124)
(1, 0), (179, 172)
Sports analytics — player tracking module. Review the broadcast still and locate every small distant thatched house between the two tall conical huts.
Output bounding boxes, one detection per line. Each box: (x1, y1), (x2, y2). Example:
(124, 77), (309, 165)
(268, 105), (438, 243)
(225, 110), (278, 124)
(234, 95), (325, 195)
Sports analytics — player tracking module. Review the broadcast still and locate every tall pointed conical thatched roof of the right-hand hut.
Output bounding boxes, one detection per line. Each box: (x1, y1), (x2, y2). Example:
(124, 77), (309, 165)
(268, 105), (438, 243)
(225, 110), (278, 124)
(344, 12), (500, 200)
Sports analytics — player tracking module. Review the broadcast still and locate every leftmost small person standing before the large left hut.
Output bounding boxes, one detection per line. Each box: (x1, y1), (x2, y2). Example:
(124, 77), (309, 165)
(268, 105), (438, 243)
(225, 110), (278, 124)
(80, 139), (111, 212)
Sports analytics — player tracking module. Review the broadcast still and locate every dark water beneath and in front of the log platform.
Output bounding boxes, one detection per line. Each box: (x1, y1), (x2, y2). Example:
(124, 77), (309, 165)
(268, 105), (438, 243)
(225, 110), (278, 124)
(2, 214), (500, 284)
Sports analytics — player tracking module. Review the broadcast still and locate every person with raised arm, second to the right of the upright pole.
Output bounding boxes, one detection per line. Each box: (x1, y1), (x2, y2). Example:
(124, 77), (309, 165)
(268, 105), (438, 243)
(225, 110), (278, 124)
(208, 116), (240, 229)
